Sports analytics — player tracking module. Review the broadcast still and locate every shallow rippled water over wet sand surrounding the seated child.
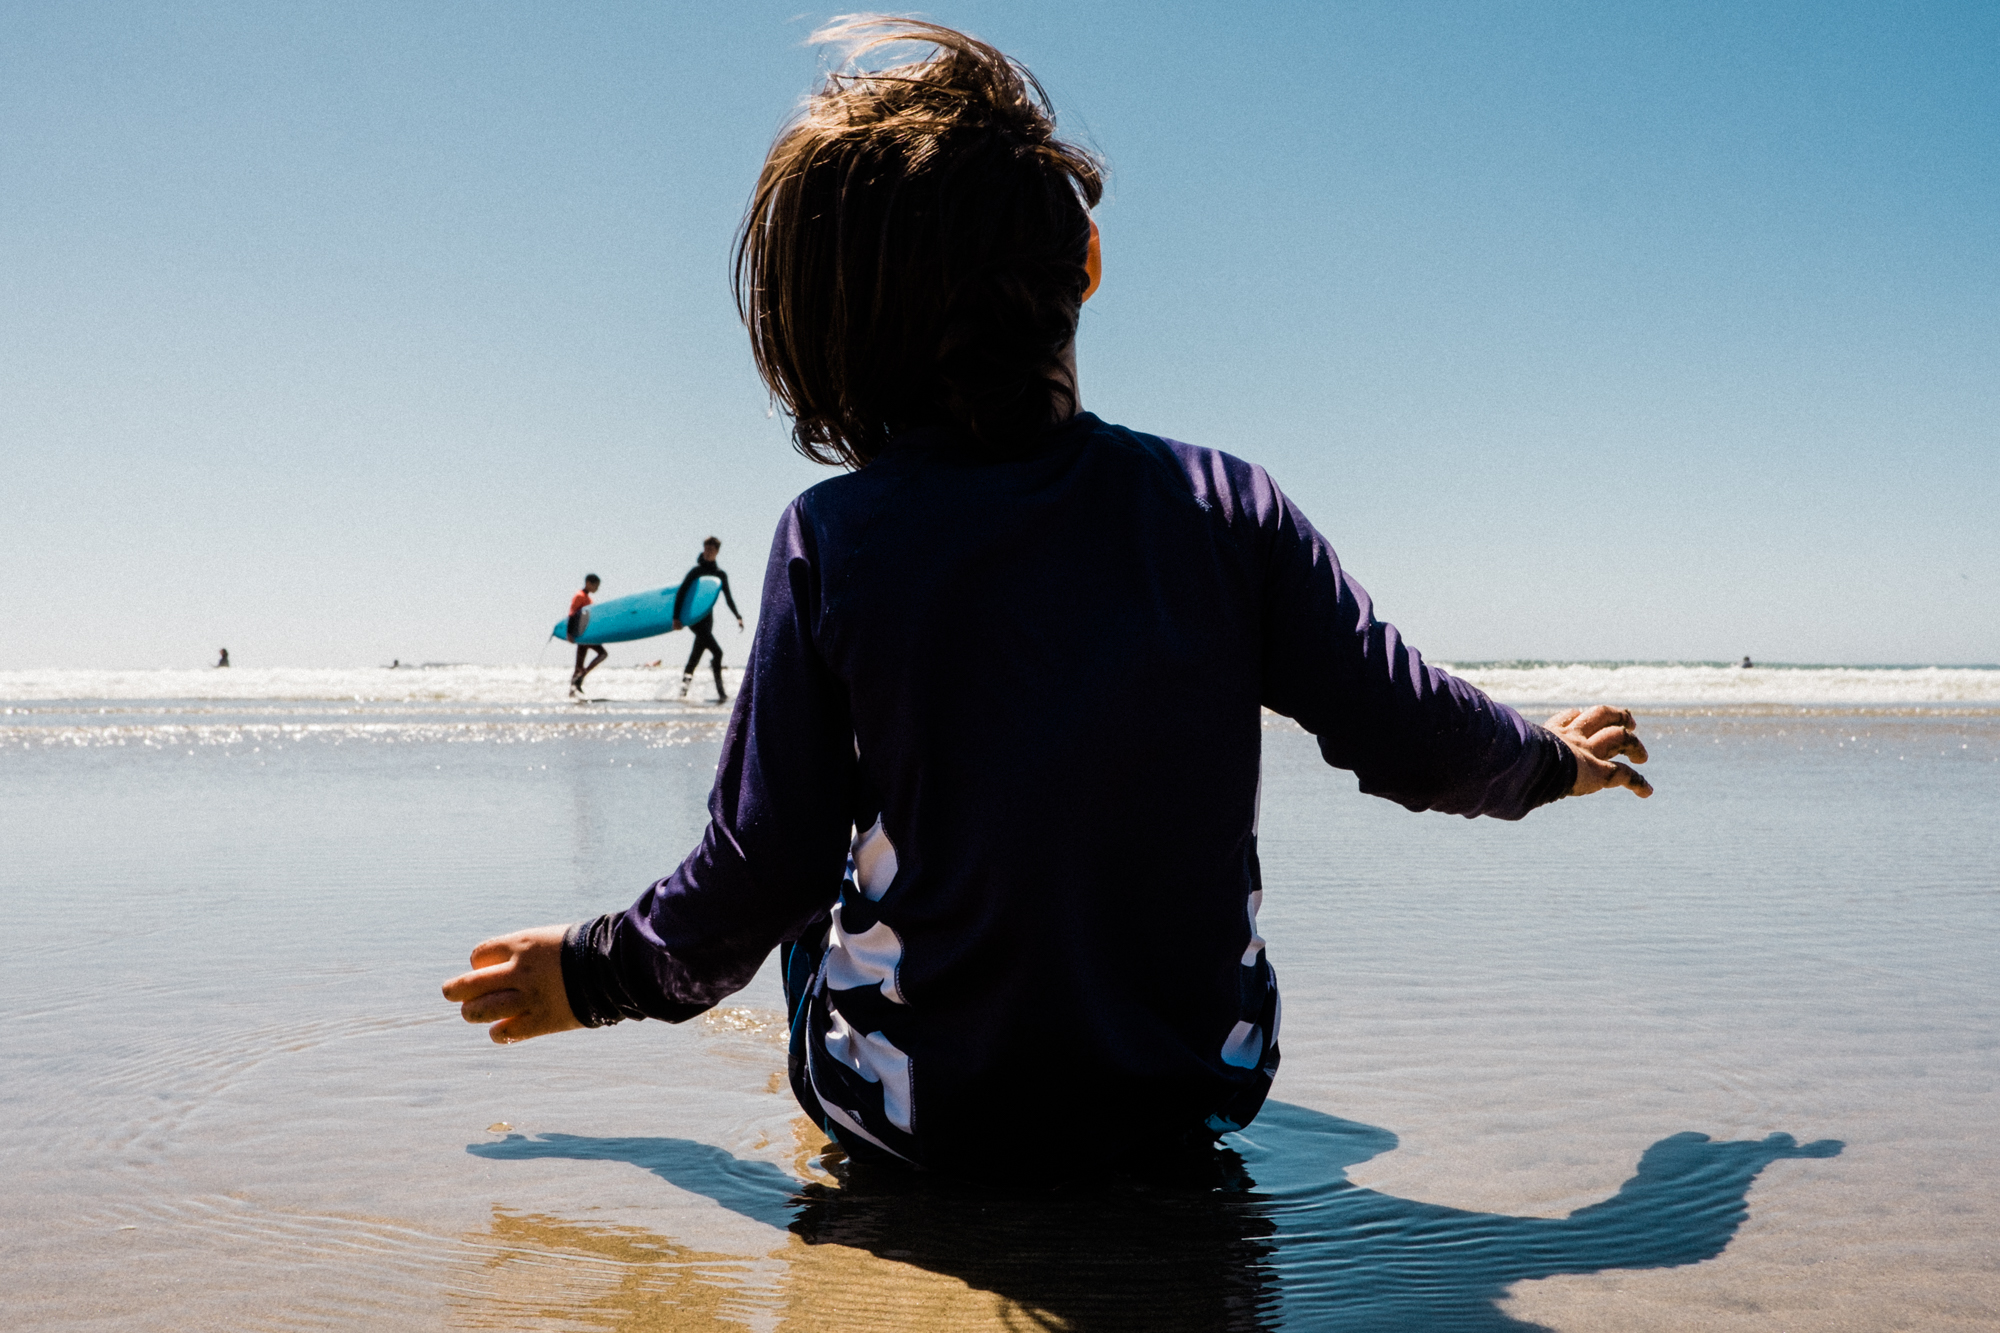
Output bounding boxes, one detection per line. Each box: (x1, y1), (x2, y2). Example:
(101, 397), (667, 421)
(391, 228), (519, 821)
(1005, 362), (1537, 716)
(0, 701), (2000, 1331)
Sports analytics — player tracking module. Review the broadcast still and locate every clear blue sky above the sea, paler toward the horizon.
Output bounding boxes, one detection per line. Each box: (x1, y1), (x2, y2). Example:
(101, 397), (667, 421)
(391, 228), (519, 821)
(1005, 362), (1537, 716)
(0, 0), (2000, 667)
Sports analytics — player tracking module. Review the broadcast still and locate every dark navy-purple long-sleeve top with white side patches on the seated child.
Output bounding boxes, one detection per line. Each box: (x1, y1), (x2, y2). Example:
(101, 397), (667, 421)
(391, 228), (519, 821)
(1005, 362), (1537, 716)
(564, 412), (1576, 1161)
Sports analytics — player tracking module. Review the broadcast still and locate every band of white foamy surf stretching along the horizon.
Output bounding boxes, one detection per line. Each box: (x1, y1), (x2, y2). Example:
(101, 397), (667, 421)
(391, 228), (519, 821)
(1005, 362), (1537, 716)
(0, 662), (2000, 709)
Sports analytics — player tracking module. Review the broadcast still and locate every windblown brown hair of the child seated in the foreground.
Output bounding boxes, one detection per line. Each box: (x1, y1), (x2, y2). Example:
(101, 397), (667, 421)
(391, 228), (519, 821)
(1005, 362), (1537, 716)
(736, 16), (1104, 466)
